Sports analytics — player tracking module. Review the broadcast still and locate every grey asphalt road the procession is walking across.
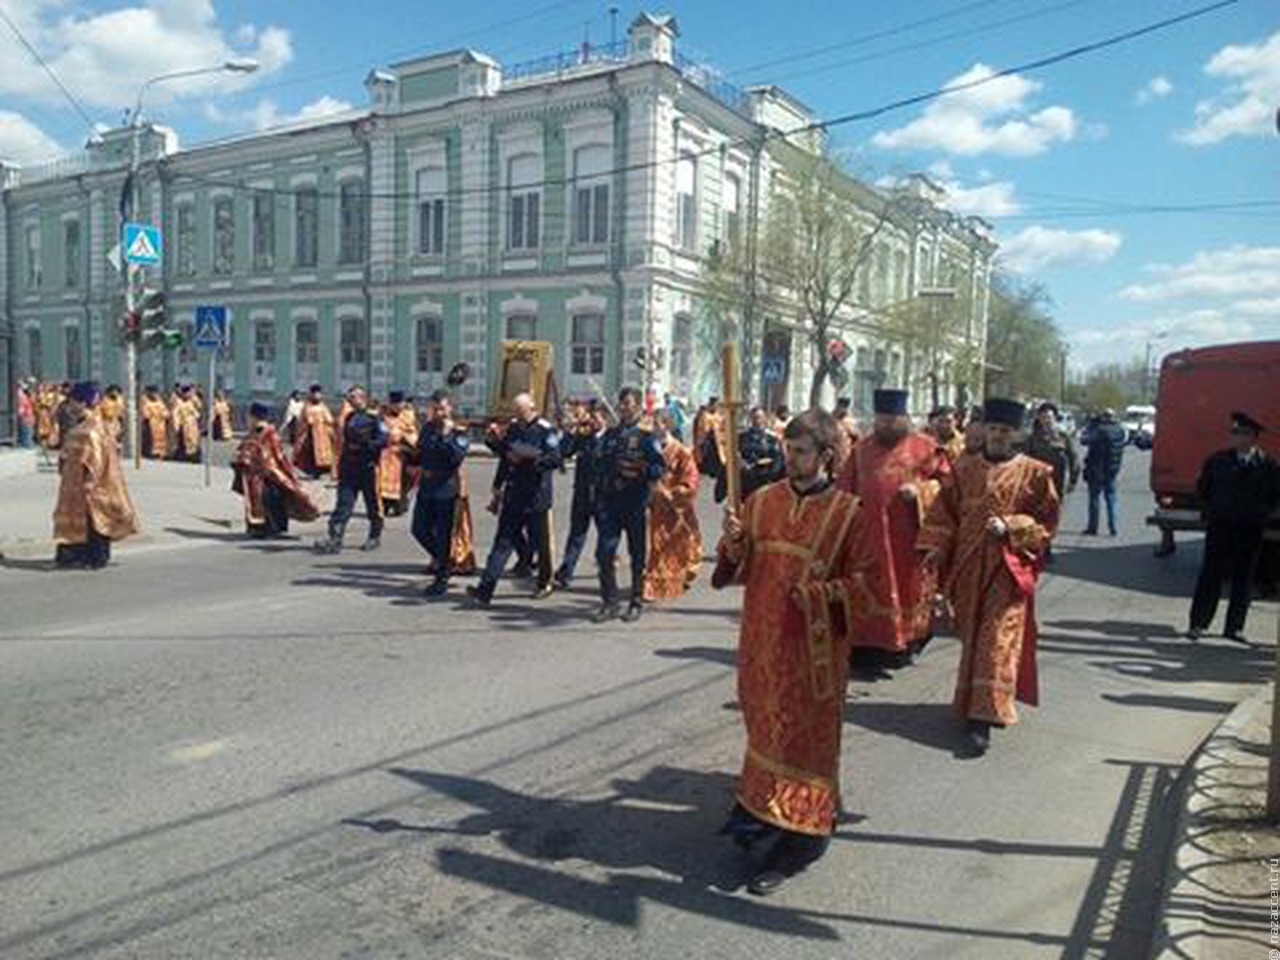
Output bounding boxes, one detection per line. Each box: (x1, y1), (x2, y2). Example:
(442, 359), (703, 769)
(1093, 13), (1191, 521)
(0, 454), (1274, 960)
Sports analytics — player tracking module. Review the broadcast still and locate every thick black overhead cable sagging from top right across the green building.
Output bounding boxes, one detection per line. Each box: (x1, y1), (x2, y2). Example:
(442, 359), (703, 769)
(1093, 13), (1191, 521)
(165, 0), (1240, 209)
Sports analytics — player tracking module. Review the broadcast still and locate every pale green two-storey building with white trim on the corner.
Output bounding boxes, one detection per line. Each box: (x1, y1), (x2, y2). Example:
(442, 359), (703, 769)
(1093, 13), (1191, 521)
(0, 15), (995, 427)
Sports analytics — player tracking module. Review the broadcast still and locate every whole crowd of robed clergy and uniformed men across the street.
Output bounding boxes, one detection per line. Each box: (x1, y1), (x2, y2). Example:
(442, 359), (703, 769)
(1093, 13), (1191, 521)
(36, 371), (1280, 895)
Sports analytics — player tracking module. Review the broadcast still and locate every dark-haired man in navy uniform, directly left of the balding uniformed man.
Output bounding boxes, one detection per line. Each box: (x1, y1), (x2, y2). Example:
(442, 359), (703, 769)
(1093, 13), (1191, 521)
(410, 390), (471, 596)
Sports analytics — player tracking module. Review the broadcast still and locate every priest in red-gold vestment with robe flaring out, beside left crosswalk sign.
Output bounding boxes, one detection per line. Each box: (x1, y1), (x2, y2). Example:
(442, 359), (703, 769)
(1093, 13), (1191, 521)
(232, 403), (320, 539)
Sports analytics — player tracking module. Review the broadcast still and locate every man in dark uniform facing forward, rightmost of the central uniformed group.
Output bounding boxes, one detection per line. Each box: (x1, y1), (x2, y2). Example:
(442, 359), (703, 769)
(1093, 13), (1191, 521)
(593, 387), (667, 623)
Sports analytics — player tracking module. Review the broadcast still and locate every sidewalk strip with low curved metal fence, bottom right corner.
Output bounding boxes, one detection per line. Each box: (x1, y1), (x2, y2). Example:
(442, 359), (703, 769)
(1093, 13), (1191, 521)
(1152, 634), (1280, 960)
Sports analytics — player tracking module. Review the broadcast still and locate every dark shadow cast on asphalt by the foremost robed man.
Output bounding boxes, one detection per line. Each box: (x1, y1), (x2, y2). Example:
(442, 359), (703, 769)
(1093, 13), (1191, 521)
(380, 767), (840, 941)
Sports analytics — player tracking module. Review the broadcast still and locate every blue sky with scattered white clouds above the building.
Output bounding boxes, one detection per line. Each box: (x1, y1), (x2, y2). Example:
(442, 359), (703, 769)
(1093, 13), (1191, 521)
(0, 0), (1280, 370)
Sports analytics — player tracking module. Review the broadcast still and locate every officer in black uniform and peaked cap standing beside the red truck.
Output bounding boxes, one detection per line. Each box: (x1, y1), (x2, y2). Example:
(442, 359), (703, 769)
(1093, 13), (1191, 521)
(1187, 411), (1280, 643)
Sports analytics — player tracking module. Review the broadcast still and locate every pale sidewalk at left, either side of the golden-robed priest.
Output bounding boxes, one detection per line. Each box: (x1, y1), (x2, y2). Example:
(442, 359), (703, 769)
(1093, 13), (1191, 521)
(0, 451), (261, 559)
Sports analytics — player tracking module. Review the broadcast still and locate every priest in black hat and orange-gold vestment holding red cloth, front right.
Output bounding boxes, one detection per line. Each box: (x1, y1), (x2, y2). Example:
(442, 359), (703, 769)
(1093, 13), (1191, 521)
(918, 398), (1059, 755)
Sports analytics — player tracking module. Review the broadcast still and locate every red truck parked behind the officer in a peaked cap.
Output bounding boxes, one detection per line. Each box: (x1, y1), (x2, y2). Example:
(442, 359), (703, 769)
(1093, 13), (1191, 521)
(1147, 340), (1280, 557)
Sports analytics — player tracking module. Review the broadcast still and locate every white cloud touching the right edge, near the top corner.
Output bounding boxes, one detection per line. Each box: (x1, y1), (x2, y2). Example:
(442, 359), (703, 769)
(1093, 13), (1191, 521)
(1176, 32), (1280, 147)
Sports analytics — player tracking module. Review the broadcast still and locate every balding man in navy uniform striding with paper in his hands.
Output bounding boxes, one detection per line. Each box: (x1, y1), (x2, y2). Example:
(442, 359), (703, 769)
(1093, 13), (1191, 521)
(467, 393), (561, 607)
